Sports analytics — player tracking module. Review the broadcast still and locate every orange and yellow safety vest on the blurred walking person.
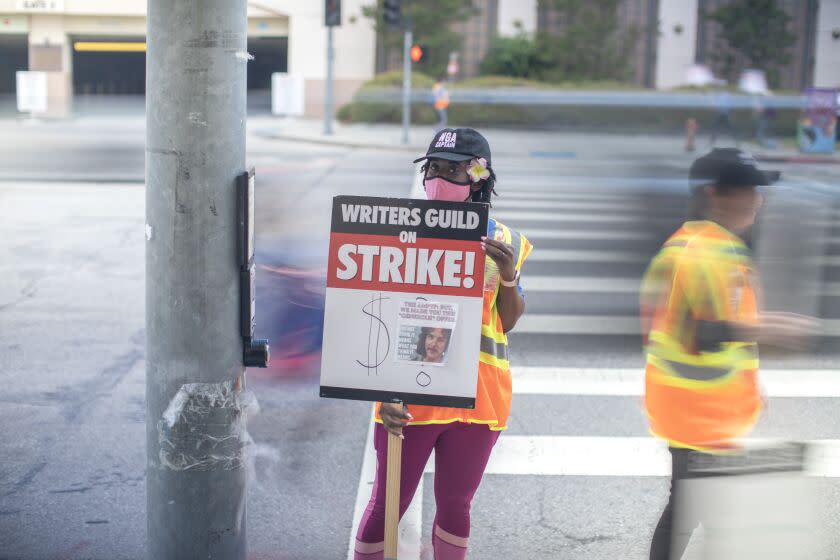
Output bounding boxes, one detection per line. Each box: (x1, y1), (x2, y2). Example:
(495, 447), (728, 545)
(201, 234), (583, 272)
(642, 221), (761, 451)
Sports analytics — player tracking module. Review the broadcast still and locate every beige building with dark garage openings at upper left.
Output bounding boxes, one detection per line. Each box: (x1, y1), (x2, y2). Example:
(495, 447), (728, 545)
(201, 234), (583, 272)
(0, 0), (375, 117)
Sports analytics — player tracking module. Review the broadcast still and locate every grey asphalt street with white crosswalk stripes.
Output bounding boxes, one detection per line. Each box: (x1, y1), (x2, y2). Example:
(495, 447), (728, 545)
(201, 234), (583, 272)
(0, 115), (840, 560)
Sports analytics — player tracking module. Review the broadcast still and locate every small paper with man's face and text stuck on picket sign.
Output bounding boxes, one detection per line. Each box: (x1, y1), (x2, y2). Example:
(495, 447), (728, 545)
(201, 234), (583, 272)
(396, 298), (458, 366)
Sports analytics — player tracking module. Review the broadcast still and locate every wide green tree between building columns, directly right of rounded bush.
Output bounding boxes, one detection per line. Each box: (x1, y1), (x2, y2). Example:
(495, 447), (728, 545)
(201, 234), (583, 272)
(537, 0), (640, 81)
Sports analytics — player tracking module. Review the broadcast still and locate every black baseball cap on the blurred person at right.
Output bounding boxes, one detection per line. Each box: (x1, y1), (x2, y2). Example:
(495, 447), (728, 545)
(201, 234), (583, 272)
(688, 148), (781, 188)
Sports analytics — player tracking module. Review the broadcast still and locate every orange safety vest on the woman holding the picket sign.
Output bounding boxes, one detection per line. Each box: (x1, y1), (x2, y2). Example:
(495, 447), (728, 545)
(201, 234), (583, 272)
(375, 219), (533, 430)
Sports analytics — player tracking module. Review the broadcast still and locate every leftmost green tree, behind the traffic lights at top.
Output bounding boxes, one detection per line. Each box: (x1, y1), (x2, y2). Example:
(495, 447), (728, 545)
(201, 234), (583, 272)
(362, 0), (476, 76)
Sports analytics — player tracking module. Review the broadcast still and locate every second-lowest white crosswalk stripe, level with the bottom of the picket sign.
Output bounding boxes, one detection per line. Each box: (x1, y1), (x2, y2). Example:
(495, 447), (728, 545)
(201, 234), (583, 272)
(512, 367), (840, 398)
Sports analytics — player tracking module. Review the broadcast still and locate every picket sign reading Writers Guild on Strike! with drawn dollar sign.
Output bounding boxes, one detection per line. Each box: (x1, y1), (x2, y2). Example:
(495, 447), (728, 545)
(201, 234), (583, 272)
(320, 196), (488, 408)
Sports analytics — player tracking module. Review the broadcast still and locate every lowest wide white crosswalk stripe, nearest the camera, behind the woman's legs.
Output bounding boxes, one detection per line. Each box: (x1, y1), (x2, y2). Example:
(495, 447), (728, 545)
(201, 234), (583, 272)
(425, 434), (840, 478)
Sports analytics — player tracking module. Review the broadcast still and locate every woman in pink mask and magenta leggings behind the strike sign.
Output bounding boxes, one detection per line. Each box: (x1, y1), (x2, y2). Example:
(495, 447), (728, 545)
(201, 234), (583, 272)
(355, 128), (532, 560)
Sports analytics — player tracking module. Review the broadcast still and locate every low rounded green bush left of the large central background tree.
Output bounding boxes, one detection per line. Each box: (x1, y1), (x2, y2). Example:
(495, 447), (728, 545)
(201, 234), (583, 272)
(479, 33), (553, 80)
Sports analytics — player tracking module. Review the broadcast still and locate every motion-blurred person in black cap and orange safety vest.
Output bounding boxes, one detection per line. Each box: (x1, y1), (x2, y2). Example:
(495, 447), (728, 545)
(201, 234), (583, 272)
(641, 148), (816, 560)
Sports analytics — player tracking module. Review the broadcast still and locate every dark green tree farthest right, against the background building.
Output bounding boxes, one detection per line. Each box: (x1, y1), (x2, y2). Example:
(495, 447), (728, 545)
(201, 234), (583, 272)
(706, 0), (796, 87)
